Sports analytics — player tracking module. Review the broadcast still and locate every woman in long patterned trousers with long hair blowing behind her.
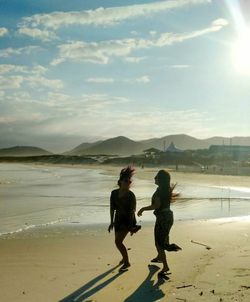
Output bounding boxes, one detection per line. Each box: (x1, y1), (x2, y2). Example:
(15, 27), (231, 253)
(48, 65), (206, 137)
(137, 170), (181, 277)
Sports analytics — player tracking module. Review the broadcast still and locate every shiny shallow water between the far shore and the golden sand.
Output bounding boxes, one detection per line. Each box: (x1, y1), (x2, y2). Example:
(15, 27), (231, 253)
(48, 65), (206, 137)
(0, 164), (250, 234)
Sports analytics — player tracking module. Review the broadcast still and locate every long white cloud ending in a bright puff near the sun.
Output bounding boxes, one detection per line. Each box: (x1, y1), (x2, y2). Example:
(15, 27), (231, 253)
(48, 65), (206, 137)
(51, 19), (228, 65)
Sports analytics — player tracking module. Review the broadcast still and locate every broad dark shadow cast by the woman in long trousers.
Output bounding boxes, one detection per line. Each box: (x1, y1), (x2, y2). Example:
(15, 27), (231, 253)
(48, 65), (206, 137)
(124, 265), (165, 302)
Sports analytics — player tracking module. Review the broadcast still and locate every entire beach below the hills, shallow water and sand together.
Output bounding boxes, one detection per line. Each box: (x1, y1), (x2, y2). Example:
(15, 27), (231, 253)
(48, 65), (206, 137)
(0, 165), (250, 302)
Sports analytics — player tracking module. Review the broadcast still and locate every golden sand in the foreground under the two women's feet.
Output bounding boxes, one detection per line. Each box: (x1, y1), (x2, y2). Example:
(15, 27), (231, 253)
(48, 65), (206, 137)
(0, 218), (250, 302)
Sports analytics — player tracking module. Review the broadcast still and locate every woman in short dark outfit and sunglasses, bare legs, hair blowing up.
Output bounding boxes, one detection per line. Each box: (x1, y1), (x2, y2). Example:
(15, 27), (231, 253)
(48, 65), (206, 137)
(108, 167), (141, 271)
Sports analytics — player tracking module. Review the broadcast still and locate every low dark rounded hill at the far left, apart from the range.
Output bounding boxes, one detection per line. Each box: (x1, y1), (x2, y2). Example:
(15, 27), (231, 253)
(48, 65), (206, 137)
(0, 146), (52, 156)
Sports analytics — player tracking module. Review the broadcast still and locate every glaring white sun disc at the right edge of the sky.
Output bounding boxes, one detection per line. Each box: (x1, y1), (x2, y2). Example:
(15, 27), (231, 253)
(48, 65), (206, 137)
(232, 30), (250, 75)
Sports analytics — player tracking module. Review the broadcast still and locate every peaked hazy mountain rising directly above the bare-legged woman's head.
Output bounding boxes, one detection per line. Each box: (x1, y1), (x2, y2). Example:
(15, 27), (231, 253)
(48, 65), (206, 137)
(70, 136), (144, 155)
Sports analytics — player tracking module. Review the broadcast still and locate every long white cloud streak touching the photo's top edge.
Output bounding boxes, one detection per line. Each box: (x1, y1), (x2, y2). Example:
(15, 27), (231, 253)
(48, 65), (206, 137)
(20, 0), (211, 30)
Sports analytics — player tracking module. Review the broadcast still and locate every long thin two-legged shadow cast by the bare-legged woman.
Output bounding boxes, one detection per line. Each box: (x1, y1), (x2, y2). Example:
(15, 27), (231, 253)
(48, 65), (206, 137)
(59, 265), (122, 302)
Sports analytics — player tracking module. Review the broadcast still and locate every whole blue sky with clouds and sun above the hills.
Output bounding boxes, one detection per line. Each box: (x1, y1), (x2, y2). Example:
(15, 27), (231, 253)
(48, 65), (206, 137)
(0, 0), (250, 152)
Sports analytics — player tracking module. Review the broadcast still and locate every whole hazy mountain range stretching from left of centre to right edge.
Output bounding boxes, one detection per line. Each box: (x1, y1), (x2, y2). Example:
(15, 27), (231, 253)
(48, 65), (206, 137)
(67, 134), (250, 156)
